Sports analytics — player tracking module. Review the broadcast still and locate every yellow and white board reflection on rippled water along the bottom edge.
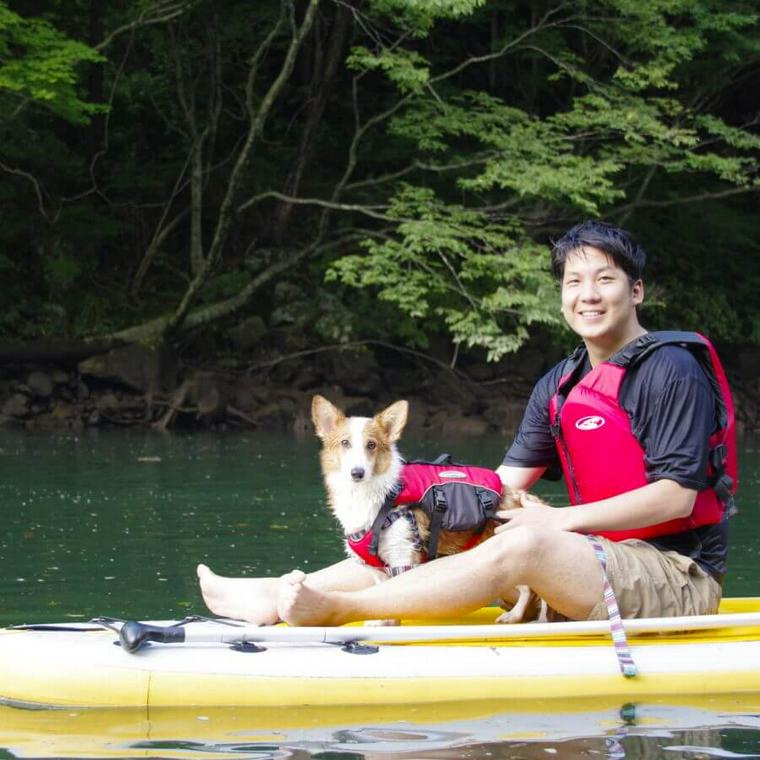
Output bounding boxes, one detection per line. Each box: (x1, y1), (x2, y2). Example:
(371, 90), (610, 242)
(0, 698), (760, 760)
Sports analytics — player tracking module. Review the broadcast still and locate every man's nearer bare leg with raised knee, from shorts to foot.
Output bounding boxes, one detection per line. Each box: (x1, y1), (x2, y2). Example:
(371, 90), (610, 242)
(277, 527), (602, 625)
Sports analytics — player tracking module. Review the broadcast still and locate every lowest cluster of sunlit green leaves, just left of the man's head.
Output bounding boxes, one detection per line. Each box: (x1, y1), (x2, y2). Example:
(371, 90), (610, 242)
(327, 185), (558, 360)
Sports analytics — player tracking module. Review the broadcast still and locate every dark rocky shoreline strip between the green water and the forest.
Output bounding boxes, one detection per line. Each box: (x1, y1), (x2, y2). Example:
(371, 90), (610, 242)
(0, 346), (760, 438)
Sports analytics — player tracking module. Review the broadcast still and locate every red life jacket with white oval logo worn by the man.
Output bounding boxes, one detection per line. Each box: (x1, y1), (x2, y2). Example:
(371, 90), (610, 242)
(549, 331), (737, 541)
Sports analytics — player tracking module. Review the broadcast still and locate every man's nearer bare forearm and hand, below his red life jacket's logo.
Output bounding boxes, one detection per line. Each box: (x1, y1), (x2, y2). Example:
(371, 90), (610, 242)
(497, 479), (697, 533)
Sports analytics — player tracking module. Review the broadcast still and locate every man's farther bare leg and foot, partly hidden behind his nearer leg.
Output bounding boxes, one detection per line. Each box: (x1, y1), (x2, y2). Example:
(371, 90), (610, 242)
(196, 559), (377, 625)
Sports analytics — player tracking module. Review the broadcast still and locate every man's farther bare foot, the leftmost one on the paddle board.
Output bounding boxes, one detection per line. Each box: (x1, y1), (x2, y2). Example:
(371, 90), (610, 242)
(196, 565), (281, 625)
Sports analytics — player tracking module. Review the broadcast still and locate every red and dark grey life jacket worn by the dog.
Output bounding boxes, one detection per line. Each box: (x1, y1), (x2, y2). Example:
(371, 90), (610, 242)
(345, 454), (503, 567)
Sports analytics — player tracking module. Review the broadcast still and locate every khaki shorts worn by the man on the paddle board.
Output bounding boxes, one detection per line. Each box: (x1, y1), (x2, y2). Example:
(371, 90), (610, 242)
(547, 537), (722, 621)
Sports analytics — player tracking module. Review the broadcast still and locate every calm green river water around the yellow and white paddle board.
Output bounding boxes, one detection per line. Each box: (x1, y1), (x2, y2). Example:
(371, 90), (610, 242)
(0, 431), (760, 760)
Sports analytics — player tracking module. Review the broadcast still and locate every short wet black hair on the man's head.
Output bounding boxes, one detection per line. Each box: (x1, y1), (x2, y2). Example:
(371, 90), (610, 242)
(552, 219), (647, 282)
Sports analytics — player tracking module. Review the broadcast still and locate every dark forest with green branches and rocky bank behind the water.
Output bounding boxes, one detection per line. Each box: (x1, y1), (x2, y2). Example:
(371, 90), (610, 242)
(0, 0), (760, 433)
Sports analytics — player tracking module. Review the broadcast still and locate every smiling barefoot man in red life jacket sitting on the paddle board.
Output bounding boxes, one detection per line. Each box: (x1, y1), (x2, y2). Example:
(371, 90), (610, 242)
(198, 221), (736, 625)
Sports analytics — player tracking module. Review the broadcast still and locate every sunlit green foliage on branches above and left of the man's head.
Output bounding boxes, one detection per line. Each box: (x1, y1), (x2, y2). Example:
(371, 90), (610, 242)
(328, 0), (760, 359)
